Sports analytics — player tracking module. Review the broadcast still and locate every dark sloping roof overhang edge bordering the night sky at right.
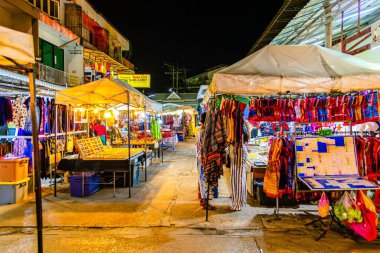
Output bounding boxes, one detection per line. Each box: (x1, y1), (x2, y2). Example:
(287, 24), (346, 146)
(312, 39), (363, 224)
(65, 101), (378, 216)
(248, 0), (309, 55)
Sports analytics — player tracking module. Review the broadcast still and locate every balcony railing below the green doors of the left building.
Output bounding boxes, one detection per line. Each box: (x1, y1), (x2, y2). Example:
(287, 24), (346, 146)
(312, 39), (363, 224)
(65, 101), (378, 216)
(38, 63), (83, 87)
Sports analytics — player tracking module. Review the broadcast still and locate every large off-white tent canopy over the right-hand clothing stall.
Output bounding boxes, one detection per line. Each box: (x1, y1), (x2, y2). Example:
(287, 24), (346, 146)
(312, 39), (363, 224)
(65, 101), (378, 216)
(209, 45), (380, 95)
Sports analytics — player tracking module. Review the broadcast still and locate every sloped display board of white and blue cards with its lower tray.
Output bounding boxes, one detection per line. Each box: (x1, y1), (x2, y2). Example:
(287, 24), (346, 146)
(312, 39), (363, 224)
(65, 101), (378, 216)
(295, 136), (380, 190)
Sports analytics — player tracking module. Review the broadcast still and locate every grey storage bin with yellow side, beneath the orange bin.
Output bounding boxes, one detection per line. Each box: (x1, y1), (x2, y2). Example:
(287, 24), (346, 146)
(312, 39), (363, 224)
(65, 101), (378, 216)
(0, 179), (29, 205)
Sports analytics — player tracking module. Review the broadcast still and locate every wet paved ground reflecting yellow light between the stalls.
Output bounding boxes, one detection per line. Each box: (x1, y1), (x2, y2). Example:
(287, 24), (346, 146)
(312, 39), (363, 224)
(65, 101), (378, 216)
(0, 139), (380, 253)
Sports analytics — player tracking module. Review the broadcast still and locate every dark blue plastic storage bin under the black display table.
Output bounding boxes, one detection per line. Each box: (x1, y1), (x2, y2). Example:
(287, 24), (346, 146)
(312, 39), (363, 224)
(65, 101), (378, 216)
(69, 174), (100, 197)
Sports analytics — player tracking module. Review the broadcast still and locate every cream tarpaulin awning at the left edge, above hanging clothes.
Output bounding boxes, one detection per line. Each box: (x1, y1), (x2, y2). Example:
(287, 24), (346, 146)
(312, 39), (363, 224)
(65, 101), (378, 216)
(0, 26), (35, 65)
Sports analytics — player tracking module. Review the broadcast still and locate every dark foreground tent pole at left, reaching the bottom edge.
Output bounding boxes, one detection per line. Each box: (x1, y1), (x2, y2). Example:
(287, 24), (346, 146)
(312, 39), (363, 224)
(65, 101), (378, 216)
(28, 65), (43, 253)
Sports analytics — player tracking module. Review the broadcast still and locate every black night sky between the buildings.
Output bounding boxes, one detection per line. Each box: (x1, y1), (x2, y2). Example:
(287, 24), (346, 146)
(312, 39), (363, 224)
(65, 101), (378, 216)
(88, 0), (283, 93)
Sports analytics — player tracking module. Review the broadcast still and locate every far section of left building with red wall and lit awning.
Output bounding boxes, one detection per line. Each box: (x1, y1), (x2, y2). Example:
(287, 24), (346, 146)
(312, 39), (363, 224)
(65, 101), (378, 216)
(60, 0), (134, 83)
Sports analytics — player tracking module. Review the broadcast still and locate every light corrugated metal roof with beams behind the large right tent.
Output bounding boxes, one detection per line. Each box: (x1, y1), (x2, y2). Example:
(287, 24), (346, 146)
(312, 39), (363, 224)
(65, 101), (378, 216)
(271, 0), (380, 51)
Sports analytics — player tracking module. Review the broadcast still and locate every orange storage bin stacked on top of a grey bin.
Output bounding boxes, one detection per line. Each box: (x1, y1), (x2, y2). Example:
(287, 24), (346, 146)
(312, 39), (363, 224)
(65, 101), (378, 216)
(0, 158), (29, 182)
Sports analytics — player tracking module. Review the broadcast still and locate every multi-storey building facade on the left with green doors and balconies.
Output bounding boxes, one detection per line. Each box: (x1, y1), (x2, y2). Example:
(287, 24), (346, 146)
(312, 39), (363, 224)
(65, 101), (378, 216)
(0, 0), (134, 95)
